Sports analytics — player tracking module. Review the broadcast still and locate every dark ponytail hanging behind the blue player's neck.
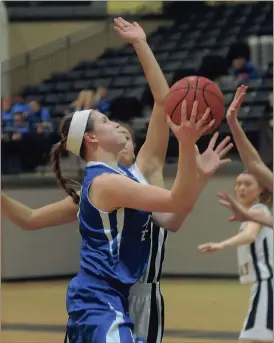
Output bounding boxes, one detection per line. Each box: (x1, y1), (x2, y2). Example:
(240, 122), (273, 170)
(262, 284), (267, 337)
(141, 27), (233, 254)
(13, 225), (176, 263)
(51, 140), (81, 205)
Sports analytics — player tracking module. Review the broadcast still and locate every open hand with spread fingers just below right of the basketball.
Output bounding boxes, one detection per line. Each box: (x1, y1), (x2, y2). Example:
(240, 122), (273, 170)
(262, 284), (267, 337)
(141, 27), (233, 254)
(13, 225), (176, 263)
(197, 132), (233, 178)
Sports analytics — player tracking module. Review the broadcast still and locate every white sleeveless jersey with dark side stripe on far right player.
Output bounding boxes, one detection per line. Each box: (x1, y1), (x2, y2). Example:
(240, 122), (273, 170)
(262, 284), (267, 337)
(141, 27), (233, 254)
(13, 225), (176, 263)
(237, 203), (273, 283)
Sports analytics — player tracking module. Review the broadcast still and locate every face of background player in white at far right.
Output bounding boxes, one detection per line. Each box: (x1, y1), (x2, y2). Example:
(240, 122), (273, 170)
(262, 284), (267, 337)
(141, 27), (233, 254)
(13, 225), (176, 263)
(235, 174), (263, 208)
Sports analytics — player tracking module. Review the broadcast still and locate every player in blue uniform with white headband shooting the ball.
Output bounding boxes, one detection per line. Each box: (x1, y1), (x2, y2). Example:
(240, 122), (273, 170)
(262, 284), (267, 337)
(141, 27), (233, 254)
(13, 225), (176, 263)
(48, 94), (217, 343)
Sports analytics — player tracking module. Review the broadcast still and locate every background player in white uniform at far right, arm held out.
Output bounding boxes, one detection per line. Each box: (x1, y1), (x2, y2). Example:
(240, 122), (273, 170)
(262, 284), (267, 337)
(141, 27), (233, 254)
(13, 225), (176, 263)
(198, 171), (273, 342)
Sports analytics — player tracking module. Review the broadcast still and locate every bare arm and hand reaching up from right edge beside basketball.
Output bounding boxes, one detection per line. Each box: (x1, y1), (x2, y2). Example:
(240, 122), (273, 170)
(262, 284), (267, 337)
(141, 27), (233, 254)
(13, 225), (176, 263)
(226, 86), (273, 192)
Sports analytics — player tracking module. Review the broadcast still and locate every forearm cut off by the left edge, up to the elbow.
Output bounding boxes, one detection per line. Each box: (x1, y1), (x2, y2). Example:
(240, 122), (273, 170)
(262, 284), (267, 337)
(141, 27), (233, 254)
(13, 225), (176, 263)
(1, 193), (33, 230)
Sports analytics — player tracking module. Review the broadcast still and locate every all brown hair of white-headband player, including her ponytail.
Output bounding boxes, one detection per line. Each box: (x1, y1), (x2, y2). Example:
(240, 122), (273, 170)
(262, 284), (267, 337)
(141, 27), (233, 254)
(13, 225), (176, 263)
(51, 113), (94, 204)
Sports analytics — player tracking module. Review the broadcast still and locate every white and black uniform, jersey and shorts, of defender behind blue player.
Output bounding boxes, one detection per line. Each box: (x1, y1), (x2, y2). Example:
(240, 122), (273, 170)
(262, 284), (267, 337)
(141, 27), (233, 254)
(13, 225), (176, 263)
(129, 164), (167, 343)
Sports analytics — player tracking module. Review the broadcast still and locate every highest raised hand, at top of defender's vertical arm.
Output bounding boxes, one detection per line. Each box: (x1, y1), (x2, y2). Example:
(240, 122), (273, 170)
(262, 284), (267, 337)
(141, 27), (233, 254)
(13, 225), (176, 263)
(114, 17), (146, 44)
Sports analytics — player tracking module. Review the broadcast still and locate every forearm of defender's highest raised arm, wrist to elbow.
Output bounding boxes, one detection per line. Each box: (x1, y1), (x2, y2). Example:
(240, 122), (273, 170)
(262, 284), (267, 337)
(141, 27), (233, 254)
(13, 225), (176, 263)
(133, 40), (169, 104)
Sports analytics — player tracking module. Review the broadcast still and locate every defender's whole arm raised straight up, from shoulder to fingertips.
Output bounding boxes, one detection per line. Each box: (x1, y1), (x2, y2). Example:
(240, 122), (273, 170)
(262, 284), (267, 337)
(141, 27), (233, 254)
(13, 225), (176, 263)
(114, 18), (169, 181)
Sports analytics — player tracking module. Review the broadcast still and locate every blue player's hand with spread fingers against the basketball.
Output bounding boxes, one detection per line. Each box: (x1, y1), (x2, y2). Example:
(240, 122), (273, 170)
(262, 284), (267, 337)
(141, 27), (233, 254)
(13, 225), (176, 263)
(167, 100), (215, 144)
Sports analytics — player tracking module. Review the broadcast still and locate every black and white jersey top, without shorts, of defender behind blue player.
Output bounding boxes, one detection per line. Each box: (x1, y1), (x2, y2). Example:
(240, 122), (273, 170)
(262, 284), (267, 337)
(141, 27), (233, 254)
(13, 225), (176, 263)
(129, 163), (167, 283)
